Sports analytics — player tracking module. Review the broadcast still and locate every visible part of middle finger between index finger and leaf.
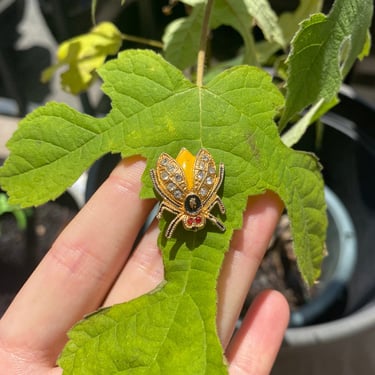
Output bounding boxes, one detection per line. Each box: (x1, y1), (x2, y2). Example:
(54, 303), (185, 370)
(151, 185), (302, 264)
(104, 222), (164, 306)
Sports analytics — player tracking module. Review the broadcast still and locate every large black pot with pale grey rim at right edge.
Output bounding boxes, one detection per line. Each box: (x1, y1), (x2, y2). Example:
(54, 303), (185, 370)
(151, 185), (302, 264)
(272, 95), (375, 375)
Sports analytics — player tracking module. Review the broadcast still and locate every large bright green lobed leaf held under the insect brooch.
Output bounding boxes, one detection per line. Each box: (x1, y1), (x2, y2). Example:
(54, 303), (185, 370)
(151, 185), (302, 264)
(0, 51), (326, 375)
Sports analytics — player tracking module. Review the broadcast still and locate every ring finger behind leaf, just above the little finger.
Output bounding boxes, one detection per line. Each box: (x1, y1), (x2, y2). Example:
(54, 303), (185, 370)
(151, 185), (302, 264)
(217, 192), (283, 348)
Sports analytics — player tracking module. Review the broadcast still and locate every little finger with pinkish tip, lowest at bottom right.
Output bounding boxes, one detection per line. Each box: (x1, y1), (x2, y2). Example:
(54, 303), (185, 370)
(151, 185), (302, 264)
(227, 291), (289, 375)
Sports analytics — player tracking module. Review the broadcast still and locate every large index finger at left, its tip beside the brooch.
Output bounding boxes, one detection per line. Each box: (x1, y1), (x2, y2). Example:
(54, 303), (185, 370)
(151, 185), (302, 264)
(0, 158), (154, 358)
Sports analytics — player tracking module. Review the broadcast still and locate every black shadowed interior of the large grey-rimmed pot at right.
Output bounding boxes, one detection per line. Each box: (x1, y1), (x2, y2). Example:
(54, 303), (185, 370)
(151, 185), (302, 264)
(296, 92), (375, 318)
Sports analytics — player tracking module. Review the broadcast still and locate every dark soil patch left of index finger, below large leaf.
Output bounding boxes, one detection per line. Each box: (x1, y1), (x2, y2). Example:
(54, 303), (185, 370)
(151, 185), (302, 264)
(0, 195), (78, 316)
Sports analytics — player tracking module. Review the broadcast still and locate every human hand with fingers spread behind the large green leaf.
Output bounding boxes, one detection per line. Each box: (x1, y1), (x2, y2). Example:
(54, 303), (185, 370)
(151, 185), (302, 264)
(0, 157), (289, 375)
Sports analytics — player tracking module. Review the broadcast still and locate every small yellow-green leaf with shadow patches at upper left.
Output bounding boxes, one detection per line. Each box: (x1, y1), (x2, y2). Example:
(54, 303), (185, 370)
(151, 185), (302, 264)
(42, 21), (122, 94)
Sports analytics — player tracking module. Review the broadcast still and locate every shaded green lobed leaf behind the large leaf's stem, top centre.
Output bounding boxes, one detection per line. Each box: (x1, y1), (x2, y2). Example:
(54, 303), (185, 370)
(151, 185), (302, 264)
(163, 0), (286, 69)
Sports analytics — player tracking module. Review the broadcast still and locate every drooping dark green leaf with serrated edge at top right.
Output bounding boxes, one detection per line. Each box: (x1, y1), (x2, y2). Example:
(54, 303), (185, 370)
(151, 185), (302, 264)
(280, 0), (373, 128)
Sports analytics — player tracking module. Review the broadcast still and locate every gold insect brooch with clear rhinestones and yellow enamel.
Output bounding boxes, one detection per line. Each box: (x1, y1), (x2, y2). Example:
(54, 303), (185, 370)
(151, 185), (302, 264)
(150, 148), (225, 238)
